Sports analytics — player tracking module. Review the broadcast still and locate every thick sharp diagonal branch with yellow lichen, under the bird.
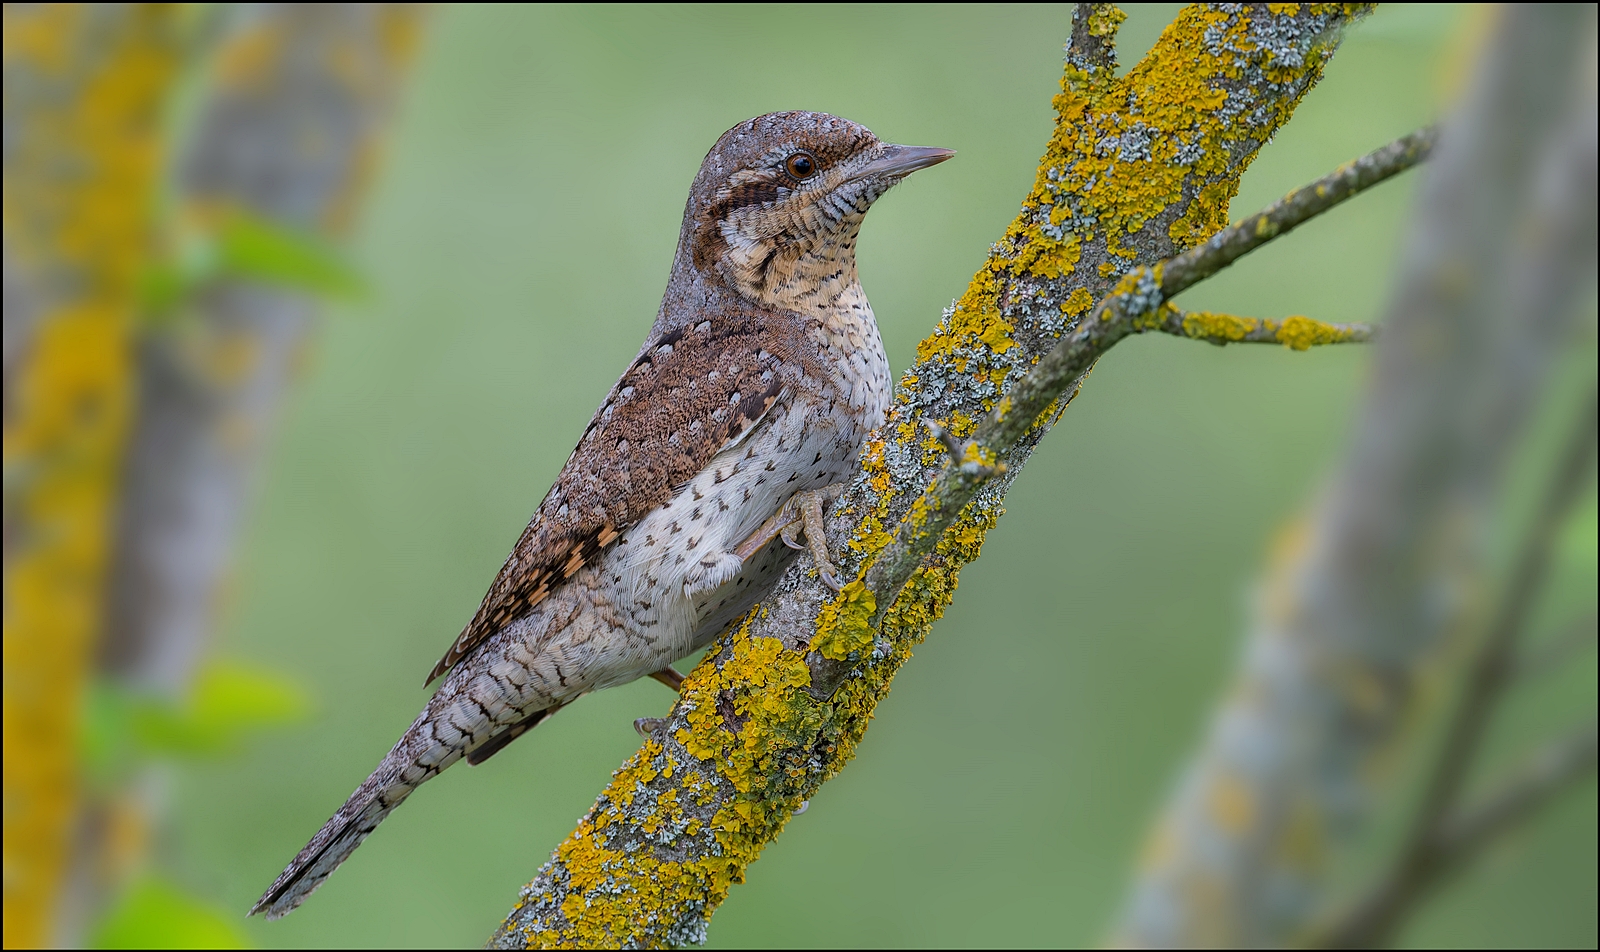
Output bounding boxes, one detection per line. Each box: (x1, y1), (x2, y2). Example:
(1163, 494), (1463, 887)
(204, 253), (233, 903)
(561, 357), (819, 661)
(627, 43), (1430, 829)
(493, 5), (1365, 947)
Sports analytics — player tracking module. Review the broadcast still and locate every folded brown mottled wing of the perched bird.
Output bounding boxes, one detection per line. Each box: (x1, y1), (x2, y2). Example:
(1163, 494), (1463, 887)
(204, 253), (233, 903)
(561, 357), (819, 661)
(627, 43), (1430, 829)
(427, 314), (814, 682)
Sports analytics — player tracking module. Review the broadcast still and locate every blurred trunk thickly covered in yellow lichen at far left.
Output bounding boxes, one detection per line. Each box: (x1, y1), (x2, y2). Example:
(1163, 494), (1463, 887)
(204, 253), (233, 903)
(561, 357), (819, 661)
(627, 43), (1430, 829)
(3, 3), (179, 949)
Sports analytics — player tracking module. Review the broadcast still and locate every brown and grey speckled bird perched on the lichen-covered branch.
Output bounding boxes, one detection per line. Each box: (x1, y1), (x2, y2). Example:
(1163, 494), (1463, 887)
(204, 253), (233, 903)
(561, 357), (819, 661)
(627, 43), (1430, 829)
(250, 112), (954, 918)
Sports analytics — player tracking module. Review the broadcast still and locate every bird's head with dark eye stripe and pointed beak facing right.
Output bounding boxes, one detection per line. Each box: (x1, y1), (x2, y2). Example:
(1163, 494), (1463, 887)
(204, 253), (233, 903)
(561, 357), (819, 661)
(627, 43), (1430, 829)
(678, 112), (955, 309)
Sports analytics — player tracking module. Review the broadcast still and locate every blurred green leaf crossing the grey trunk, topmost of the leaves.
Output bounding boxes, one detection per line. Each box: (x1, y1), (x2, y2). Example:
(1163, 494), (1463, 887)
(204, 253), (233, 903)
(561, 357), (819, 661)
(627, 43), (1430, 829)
(218, 213), (366, 299)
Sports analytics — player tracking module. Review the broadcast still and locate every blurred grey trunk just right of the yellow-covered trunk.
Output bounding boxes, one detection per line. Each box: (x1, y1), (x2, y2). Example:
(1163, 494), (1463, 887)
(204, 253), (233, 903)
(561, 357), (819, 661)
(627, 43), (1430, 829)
(74, 3), (422, 940)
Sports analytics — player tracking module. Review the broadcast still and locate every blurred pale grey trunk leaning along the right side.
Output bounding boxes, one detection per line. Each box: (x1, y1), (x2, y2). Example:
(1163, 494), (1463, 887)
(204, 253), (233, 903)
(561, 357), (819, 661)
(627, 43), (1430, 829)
(1114, 6), (1595, 947)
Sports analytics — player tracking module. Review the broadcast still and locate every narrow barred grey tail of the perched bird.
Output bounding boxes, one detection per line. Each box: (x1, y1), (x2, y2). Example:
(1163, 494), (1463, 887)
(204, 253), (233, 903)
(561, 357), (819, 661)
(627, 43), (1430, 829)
(250, 704), (444, 918)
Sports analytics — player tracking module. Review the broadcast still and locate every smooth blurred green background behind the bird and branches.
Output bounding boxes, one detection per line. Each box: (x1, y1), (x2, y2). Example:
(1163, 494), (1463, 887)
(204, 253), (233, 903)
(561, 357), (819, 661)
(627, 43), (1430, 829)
(170, 5), (1597, 947)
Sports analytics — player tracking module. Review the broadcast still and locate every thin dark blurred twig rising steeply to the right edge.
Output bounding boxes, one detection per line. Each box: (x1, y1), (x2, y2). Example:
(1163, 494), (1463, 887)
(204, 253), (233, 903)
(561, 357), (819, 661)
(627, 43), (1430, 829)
(1317, 390), (1600, 949)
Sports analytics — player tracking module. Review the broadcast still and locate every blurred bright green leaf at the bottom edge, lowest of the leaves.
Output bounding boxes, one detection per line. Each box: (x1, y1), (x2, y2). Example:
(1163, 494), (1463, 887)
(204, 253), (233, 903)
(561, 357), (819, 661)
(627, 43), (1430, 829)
(90, 877), (250, 949)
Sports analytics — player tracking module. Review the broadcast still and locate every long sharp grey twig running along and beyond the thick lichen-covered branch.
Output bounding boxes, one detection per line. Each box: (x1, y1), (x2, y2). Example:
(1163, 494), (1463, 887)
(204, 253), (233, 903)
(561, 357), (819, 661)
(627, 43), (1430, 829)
(866, 126), (1437, 613)
